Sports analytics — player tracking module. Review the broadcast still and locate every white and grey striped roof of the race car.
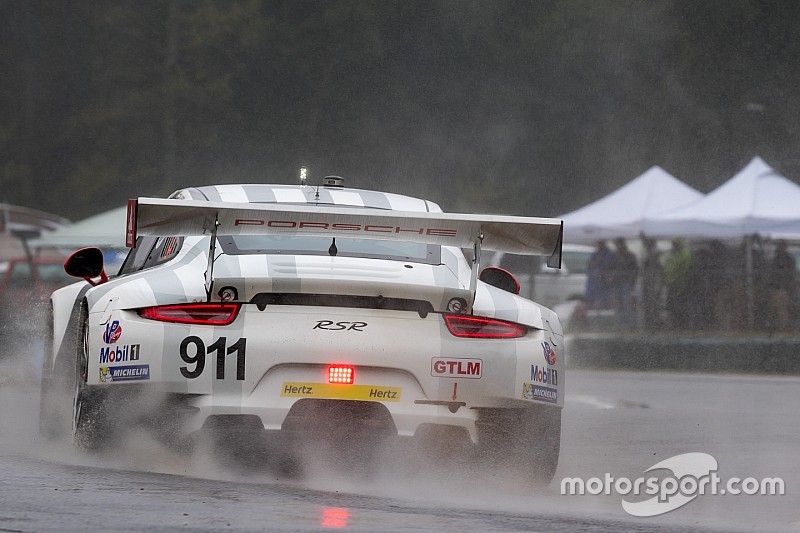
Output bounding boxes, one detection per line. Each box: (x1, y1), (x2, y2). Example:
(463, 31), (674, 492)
(170, 183), (442, 213)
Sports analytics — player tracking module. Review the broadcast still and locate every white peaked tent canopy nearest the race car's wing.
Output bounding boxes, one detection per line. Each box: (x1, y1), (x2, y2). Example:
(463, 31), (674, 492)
(559, 166), (703, 243)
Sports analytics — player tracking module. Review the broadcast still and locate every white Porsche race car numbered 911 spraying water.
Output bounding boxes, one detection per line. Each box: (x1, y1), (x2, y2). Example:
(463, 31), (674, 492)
(41, 177), (565, 482)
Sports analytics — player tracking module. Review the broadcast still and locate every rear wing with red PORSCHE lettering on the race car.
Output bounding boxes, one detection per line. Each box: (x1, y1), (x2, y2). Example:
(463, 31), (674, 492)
(126, 198), (563, 268)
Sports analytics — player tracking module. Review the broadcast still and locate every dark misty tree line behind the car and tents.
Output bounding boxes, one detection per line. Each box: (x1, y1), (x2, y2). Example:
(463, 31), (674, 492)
(0, 0), (800, 219)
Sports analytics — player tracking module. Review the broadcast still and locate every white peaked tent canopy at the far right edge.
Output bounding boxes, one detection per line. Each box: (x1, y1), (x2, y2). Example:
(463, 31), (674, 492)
(644, 157), (800, 239)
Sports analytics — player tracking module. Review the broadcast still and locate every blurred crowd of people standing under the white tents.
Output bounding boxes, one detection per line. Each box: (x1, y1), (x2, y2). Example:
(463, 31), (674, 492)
(584, 238), (800, 331)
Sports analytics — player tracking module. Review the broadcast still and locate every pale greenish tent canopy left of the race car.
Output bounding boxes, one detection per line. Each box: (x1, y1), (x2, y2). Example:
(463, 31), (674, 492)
(30, 206), (127, 248)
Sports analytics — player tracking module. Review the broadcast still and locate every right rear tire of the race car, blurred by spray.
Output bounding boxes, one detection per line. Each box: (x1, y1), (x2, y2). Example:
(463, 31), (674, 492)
(476, 405), (561, 487)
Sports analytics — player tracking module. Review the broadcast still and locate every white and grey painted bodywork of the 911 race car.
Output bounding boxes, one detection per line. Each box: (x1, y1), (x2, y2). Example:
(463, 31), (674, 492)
(48, 185), (565, 439)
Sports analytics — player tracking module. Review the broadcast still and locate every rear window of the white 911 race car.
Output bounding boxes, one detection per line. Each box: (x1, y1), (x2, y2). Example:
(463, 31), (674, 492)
(218, 235), (441, 265)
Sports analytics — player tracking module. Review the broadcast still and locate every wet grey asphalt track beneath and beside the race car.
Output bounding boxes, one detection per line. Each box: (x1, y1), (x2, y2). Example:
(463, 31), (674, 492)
(0, 362), (800, 531)
